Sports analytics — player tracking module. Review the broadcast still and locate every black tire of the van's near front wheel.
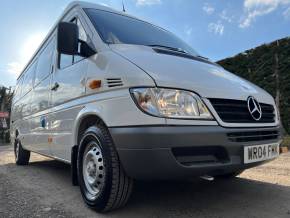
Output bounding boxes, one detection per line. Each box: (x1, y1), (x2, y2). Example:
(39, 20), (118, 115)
(77, 122), (133, 212)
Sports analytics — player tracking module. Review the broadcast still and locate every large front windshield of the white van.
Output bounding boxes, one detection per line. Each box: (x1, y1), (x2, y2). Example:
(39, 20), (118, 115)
(85, 9), (198, 56)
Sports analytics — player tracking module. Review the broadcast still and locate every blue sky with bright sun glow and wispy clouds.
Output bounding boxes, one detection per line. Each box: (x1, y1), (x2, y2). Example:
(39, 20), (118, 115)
(0, 0), (290, 87)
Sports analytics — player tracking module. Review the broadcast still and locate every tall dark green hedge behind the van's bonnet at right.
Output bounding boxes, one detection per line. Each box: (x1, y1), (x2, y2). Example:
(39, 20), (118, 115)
(218, 38), (290, 134)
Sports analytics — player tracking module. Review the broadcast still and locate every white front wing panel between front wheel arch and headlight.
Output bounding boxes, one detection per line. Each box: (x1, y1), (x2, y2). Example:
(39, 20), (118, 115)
(74, 89), (166, 145)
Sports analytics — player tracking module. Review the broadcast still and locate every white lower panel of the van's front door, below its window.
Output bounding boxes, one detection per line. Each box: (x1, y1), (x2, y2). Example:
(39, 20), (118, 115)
(50, 60), (88, 160)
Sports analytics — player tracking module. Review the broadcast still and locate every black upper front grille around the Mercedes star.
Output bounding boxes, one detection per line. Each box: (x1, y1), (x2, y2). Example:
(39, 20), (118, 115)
(209, 98), (275, 123)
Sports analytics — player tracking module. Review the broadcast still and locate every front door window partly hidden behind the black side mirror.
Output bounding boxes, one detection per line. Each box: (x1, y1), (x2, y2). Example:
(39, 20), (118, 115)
(59, 18), (88, 69)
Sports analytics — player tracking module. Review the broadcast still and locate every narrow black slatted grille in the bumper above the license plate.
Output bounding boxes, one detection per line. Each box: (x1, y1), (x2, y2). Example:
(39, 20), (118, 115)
(227, 130), (279, 142)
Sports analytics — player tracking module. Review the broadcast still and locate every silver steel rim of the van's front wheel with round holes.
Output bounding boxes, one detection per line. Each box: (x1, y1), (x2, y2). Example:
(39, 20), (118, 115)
(83, 141), (105, 200)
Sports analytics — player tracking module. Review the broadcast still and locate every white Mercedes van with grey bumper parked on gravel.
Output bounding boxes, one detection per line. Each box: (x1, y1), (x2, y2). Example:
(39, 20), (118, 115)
(11, 2), (281, 212)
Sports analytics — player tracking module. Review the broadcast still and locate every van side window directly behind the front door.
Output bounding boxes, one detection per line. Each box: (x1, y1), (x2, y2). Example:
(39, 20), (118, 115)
(35, 38), (55, 85)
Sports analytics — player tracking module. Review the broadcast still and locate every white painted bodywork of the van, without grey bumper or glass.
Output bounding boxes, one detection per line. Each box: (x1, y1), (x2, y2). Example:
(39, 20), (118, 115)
(11, 2), (279, 162)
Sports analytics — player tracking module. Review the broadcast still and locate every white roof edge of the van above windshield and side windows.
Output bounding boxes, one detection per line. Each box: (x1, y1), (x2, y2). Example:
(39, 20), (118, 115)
(17, 1), (127, 80)
